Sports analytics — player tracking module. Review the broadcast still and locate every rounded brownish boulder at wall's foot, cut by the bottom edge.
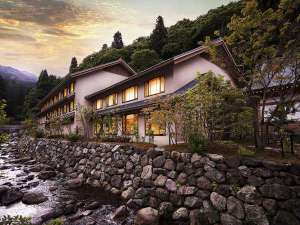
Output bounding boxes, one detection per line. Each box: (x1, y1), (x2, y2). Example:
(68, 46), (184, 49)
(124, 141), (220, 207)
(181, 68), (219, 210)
(134, 207), (159, 225)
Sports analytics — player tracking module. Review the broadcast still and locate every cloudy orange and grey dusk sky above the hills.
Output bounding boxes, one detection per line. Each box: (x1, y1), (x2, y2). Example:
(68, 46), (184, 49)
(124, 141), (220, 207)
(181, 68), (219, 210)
(0, 0), (231, 76)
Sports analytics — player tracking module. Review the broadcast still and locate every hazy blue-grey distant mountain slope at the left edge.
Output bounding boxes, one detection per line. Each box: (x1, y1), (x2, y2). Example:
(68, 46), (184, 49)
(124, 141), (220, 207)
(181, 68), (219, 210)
(0, 65), (37, 83)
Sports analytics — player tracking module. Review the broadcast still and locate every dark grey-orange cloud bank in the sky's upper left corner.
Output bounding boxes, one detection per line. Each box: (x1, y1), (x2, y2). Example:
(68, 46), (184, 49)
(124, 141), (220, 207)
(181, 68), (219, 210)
(0, 0), (112, 26)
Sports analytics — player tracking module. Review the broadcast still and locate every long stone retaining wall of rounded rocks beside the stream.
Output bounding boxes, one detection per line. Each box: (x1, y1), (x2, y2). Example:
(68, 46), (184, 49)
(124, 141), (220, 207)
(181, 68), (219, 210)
(19, 138), (300, 225)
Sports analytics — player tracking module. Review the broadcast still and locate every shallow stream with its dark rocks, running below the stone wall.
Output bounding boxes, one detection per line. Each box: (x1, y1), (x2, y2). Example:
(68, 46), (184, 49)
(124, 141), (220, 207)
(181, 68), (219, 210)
(0, 135), (132, 225)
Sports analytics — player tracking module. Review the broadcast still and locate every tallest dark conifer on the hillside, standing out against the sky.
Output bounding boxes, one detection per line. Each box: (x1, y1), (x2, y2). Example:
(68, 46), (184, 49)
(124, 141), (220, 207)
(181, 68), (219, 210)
(150, 16), (168, 55)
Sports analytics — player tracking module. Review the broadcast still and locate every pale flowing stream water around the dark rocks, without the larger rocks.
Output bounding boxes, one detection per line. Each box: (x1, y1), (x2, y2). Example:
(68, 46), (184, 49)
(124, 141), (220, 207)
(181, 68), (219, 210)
(0, 143), (132, 225)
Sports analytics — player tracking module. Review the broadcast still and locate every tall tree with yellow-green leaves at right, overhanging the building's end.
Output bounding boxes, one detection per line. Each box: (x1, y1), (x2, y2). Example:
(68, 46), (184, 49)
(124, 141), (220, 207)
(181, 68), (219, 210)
(226, 0), (300, 149)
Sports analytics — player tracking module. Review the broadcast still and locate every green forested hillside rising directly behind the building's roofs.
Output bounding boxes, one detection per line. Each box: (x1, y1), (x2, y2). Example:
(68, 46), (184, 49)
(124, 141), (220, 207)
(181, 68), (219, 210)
(71, 1), (243, 71)
